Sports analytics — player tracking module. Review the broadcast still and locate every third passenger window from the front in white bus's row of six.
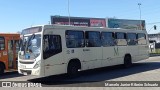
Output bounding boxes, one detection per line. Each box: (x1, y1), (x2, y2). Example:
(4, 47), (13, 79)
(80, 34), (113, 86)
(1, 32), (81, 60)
(102, 32), (114, 47)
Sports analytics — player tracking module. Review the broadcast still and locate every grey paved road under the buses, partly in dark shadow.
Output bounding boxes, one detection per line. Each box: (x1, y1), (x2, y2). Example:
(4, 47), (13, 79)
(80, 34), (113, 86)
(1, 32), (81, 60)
(0, 56), (160, 90)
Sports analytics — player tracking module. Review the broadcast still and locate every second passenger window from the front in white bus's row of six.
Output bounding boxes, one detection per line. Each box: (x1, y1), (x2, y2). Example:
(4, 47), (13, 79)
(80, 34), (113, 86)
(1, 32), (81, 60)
(86, 31), (101, 47)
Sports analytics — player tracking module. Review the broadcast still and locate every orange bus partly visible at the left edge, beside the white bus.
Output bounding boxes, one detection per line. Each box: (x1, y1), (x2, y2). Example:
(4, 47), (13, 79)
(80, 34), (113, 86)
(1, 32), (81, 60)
(0, 33), (20, 74)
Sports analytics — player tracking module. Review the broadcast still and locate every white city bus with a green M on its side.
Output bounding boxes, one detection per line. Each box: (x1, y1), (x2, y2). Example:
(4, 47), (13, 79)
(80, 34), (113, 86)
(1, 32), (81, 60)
(18, 25), (149, 77)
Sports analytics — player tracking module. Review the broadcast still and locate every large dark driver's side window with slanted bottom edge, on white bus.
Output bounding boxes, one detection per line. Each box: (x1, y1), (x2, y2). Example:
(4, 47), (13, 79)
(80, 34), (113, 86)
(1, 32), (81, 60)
(43, 35), (62, 59)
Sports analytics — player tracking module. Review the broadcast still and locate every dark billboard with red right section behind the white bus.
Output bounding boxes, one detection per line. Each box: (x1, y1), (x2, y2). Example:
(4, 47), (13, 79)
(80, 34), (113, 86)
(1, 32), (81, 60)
(51, 15), (106, 27)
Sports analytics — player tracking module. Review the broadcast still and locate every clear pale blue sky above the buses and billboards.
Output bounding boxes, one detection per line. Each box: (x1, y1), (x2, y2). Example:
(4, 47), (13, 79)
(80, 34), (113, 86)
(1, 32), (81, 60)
(0, 0), (160, 33)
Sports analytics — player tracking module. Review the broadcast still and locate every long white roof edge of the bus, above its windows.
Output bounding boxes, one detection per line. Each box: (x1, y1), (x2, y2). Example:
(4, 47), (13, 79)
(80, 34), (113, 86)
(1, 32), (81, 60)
(22, 24), (147, 34)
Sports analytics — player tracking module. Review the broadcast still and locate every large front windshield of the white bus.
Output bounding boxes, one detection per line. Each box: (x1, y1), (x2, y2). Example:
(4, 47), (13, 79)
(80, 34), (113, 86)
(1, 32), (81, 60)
(19, 34), (41, 59)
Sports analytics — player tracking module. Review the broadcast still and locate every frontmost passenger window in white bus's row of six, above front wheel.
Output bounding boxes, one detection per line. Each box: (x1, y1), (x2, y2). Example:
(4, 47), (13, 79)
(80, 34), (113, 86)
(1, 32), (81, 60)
(66, 30), (84, 48)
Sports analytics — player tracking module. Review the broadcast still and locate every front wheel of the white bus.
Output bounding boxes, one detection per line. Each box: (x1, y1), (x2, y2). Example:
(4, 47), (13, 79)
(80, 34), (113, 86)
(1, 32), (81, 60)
(67, 62), (79, 78)
